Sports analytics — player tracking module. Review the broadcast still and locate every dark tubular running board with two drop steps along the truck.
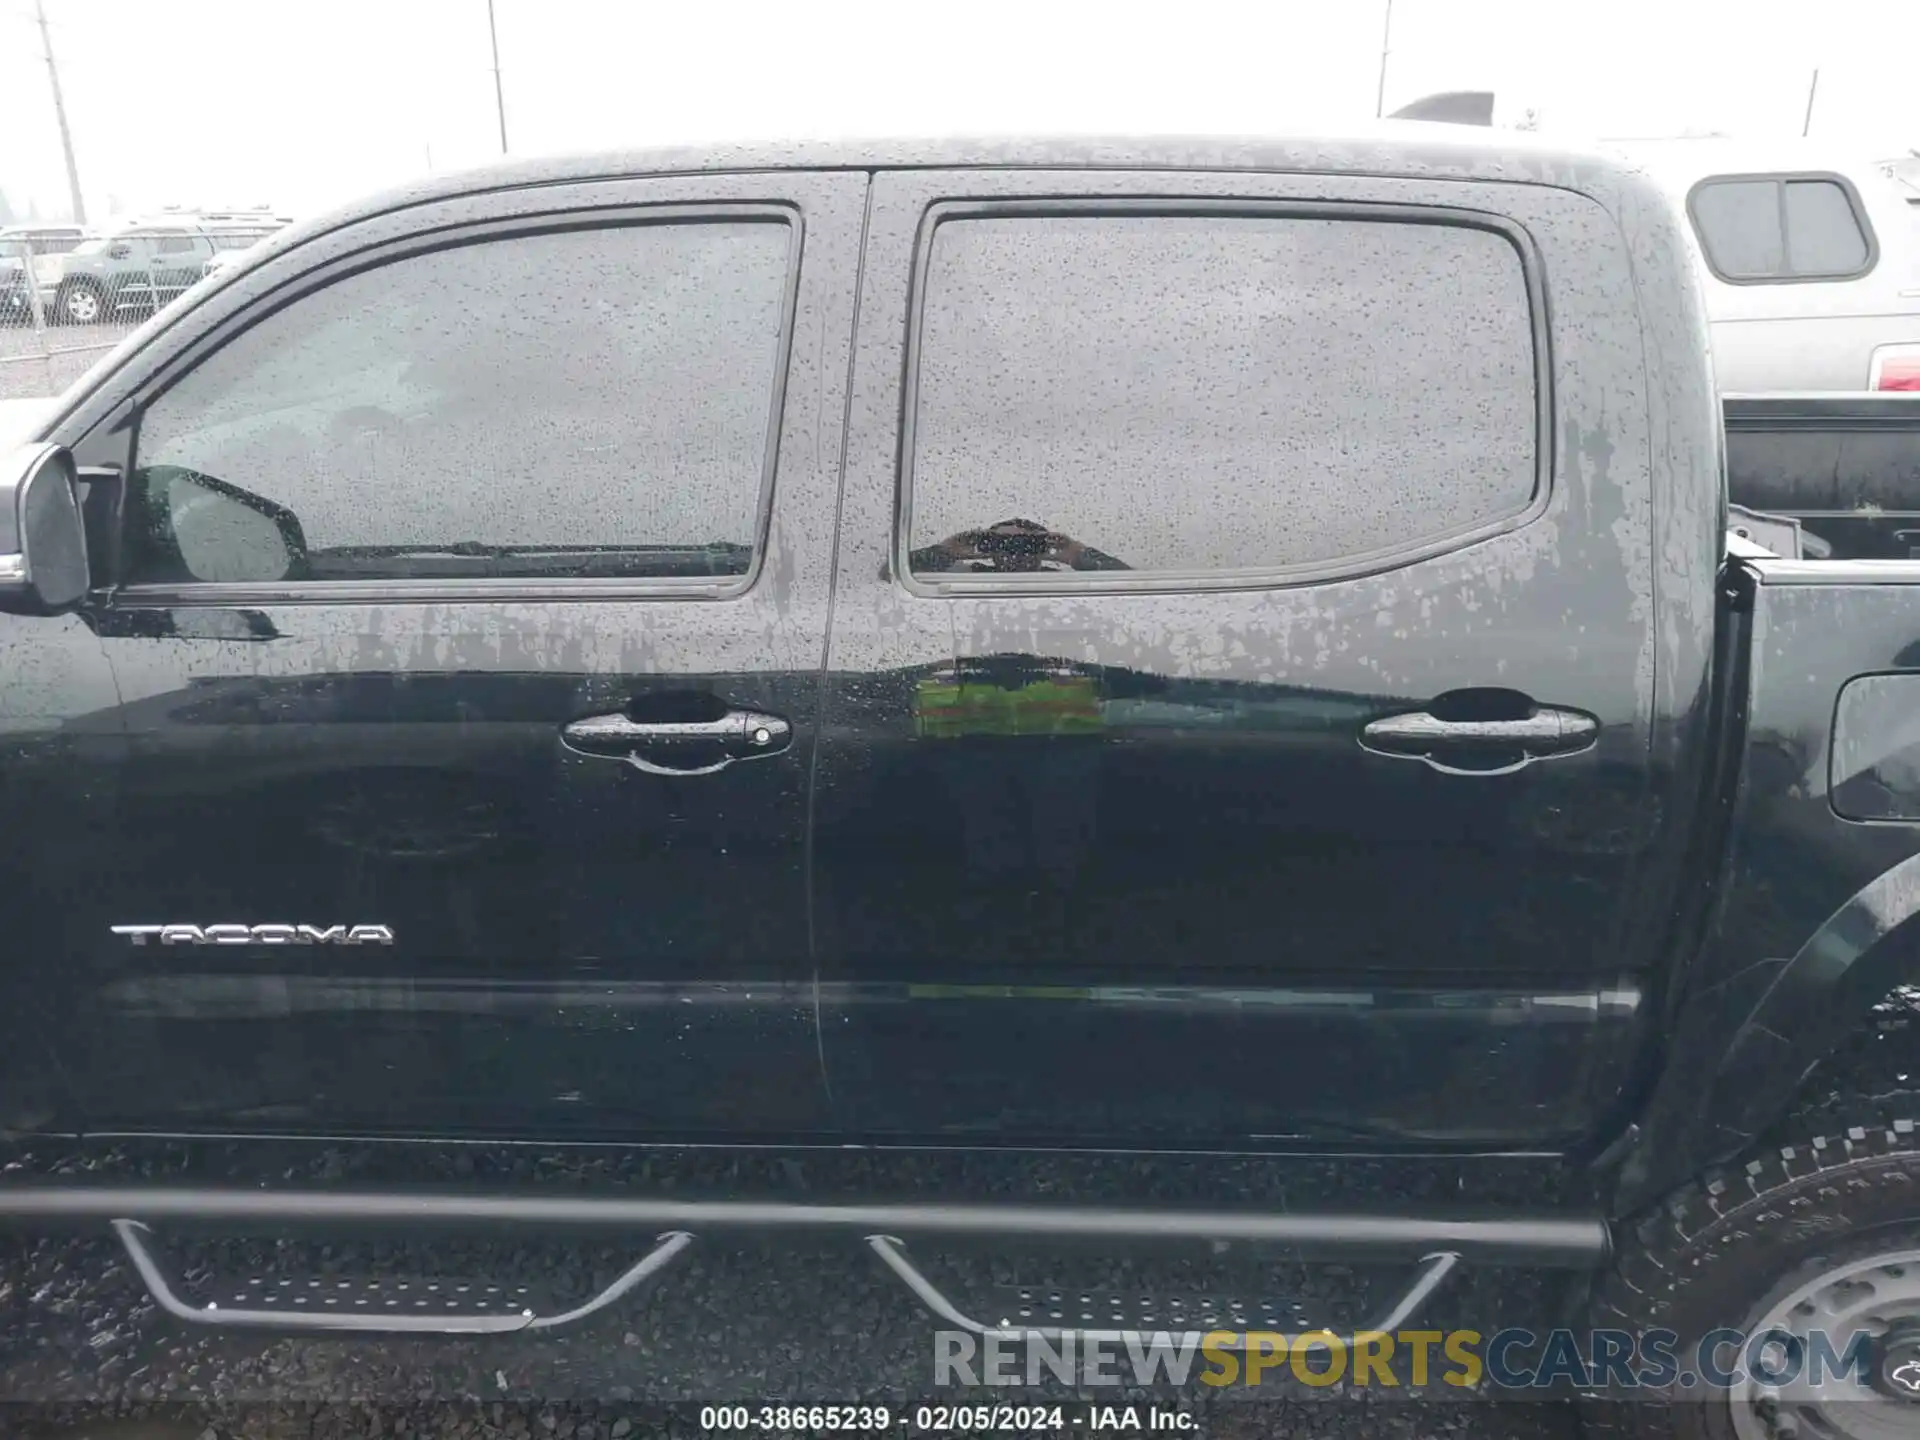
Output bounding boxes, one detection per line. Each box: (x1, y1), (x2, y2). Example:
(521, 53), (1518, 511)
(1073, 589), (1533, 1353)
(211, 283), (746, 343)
(0, 1187), (1611, 1350)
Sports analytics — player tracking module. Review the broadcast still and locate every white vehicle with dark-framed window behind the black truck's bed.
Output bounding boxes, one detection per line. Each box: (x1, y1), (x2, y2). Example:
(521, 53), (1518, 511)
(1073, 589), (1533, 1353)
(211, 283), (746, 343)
(1609, 138), (1920, 394)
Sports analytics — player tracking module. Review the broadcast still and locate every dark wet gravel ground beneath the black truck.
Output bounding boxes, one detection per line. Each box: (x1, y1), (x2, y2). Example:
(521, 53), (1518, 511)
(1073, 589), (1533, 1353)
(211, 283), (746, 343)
(0, 1146), (1574, 1440)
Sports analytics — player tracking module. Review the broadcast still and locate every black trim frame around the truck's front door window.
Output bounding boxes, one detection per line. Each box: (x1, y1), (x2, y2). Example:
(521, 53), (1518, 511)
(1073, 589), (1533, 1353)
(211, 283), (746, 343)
(111, 200), (804, 607)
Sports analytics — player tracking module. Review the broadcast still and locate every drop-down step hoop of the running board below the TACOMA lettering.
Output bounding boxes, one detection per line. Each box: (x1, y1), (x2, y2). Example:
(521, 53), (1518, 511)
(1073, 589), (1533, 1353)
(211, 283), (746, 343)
(113, 1219), (693, 1334)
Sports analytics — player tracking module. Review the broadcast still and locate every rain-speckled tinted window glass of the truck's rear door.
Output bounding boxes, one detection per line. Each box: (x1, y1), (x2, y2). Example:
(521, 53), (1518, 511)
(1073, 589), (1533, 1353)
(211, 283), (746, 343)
(910, 215), (1538, 572)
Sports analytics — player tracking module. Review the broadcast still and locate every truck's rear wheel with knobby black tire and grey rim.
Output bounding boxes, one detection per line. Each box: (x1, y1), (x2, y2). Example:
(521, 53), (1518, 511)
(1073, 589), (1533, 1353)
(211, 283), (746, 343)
(1584, 1096), (1920, 1440)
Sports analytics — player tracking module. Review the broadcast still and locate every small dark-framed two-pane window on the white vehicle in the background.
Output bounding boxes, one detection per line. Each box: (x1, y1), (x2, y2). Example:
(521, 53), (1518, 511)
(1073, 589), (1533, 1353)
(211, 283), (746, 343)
(1688, 173), (1878, 284)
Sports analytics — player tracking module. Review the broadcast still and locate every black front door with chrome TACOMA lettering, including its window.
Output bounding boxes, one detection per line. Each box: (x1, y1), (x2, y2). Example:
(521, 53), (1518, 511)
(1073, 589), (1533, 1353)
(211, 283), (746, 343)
(46, 175), (864, 1139)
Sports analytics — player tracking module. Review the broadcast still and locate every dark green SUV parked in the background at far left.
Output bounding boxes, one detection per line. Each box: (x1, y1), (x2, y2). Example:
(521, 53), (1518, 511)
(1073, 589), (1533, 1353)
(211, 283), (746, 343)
(42, 213), (286, 324)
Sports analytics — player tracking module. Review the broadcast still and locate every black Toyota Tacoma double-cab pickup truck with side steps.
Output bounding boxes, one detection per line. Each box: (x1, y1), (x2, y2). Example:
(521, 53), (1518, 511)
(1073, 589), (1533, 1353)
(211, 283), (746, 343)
(0, 127), (1920, 1440)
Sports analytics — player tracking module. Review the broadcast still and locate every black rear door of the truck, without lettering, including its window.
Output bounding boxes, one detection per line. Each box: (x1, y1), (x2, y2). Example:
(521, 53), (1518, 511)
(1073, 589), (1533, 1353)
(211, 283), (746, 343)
(816, 171), (1653, 1144)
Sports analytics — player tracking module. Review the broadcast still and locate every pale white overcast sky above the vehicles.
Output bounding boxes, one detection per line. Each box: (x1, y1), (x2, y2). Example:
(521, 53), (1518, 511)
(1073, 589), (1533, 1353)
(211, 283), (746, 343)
(0, 0), (1920, 219)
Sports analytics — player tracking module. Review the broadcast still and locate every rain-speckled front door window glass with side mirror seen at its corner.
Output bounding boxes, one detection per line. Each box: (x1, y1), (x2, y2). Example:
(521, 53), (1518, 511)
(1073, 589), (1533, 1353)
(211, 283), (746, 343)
(134, 221), (789, 580)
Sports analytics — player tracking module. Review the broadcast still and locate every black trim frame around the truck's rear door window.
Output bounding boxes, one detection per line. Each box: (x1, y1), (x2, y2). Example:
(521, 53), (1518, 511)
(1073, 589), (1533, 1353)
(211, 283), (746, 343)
(887, 196), (1553, 599)
